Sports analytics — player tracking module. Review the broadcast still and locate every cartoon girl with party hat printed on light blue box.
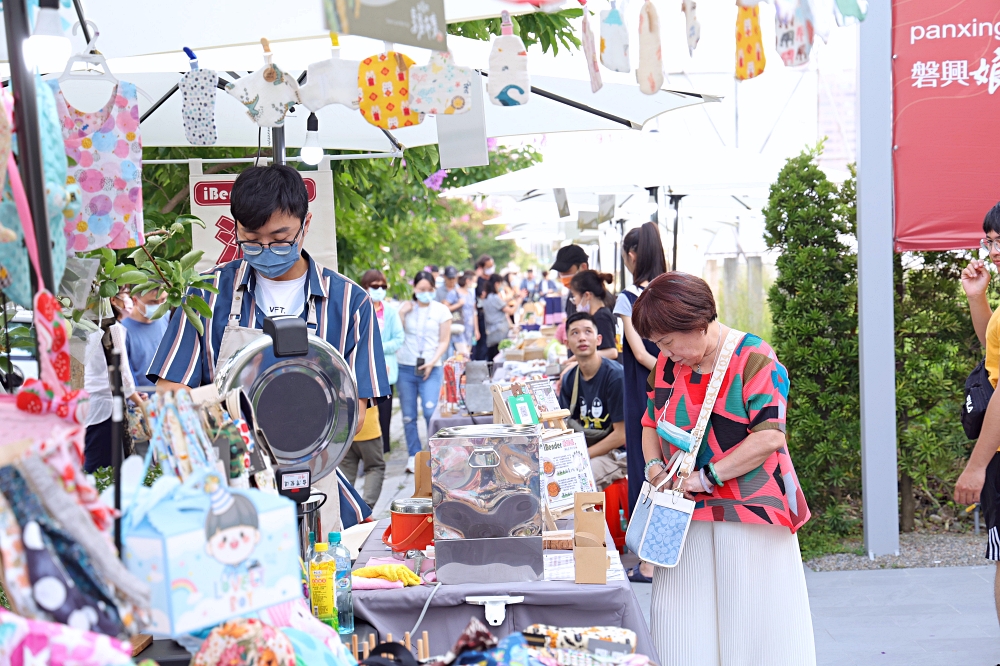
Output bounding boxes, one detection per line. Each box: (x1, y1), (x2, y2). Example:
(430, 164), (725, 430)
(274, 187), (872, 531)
(205, 476), (260, 576)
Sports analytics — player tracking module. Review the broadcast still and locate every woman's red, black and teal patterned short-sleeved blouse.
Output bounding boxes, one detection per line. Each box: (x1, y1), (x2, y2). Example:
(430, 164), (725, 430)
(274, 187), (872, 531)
(642, 334), (809, 532)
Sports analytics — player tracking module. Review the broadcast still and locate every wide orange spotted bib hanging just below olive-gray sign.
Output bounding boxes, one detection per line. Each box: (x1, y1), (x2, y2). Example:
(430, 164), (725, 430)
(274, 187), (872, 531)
(358, 51), (423, 129)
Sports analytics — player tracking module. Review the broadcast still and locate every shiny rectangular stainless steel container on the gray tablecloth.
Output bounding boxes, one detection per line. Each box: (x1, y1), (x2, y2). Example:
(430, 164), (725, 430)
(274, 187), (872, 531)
(429, 424), (543, 584)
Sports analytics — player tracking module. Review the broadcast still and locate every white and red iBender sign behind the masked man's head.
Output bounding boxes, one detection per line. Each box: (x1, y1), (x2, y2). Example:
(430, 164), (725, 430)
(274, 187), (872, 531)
(190, 160), (337, 271)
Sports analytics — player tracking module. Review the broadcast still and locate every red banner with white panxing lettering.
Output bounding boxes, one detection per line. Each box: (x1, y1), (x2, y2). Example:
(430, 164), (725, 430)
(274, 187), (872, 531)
(896, 0), (1000, 251)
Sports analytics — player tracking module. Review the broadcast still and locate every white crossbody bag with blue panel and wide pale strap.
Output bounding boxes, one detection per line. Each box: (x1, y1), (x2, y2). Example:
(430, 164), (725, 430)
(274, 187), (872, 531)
(625, 329), (745, 568)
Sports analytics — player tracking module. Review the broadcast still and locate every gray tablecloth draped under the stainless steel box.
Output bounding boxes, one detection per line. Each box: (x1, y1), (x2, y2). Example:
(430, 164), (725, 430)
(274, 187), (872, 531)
(354, 520), (660, 663)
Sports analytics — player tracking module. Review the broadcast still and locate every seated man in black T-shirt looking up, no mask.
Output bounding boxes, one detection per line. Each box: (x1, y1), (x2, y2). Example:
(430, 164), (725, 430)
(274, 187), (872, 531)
(559, 312), (626, 490)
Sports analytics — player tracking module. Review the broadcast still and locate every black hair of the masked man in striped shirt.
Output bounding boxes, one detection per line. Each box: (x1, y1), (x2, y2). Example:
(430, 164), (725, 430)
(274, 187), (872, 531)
(229, 164), (309, 231)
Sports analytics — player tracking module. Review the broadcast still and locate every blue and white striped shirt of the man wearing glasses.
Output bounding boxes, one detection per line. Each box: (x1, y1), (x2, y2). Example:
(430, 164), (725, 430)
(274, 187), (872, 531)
(147, 252), (389, 398)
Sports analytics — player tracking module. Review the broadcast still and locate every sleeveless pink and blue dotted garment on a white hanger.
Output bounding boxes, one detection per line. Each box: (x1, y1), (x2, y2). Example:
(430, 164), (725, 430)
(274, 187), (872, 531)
(56, 81), (146, 252)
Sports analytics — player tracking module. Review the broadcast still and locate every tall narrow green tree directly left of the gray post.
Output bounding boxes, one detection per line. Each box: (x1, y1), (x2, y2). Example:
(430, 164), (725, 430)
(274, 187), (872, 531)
(764, 145), (860, 514)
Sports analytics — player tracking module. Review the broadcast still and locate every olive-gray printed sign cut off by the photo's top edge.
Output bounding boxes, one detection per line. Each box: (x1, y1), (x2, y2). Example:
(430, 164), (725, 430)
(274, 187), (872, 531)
(323, 0), (448, 51)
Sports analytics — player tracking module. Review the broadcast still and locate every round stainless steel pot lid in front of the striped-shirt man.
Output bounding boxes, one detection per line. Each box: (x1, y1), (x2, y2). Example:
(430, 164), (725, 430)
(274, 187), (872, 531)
(215, 335), (358, 481)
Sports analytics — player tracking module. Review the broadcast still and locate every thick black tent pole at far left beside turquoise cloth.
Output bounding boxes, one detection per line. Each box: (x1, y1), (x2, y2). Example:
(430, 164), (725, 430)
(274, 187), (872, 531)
(3, 0), (56, 293)
